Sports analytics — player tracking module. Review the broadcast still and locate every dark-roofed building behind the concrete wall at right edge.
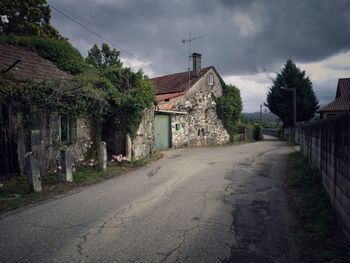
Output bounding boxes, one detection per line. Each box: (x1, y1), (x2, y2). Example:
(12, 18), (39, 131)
(319, 78), (350, 119)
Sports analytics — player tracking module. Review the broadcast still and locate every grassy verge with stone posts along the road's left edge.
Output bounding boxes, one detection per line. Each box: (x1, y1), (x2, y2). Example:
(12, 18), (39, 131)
(0, 152), (163, 214)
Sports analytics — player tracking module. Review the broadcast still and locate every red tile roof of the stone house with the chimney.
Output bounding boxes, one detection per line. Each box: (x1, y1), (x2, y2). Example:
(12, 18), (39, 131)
(151, 66), (213, 95)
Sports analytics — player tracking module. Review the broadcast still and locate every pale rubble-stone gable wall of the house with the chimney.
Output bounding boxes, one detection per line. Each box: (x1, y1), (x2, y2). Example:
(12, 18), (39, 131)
(158, 69), (230, 147)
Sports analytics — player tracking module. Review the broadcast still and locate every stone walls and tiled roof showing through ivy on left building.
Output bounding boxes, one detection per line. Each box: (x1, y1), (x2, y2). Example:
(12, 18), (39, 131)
(0, 44), (154, 178)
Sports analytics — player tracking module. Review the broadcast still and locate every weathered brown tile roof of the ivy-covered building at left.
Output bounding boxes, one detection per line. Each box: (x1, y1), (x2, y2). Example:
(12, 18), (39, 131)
(0, 44), (72, 82)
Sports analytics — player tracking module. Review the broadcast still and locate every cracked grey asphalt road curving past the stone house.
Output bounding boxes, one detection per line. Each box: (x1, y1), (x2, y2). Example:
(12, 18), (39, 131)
(0, 136), (300, 263)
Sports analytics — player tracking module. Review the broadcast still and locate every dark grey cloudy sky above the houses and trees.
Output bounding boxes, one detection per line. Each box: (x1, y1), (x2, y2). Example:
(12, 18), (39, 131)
(48, 0), (350, 112)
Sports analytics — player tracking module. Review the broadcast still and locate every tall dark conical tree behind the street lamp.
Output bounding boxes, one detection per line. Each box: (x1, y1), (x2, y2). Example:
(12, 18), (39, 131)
(266, 59), (319, 127)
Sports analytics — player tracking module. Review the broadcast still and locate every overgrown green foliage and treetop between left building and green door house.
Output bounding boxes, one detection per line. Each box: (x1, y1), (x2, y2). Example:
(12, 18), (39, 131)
(86, 44), (156, 138)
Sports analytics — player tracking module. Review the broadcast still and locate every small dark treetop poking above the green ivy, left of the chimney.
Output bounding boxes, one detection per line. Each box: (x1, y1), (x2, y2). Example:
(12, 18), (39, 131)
(86, 43), (123, 69)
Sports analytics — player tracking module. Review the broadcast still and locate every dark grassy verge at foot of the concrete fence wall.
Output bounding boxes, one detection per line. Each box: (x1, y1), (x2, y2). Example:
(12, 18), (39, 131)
(286, 152), (350, 263)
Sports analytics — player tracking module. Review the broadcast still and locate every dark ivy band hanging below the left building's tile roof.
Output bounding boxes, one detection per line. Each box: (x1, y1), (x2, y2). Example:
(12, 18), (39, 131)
(0, 73), (107, 126)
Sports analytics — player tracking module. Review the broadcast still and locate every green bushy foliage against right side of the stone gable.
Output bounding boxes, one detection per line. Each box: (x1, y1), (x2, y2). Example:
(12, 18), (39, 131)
(216, 82), (242, 141)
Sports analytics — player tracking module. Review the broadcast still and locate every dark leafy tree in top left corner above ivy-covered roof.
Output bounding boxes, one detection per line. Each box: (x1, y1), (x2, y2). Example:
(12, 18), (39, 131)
(0, 0), (63, 39)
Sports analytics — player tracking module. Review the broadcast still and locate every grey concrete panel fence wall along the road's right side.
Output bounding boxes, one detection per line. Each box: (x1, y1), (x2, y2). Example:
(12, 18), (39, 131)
(295, 113), (350, 240)
